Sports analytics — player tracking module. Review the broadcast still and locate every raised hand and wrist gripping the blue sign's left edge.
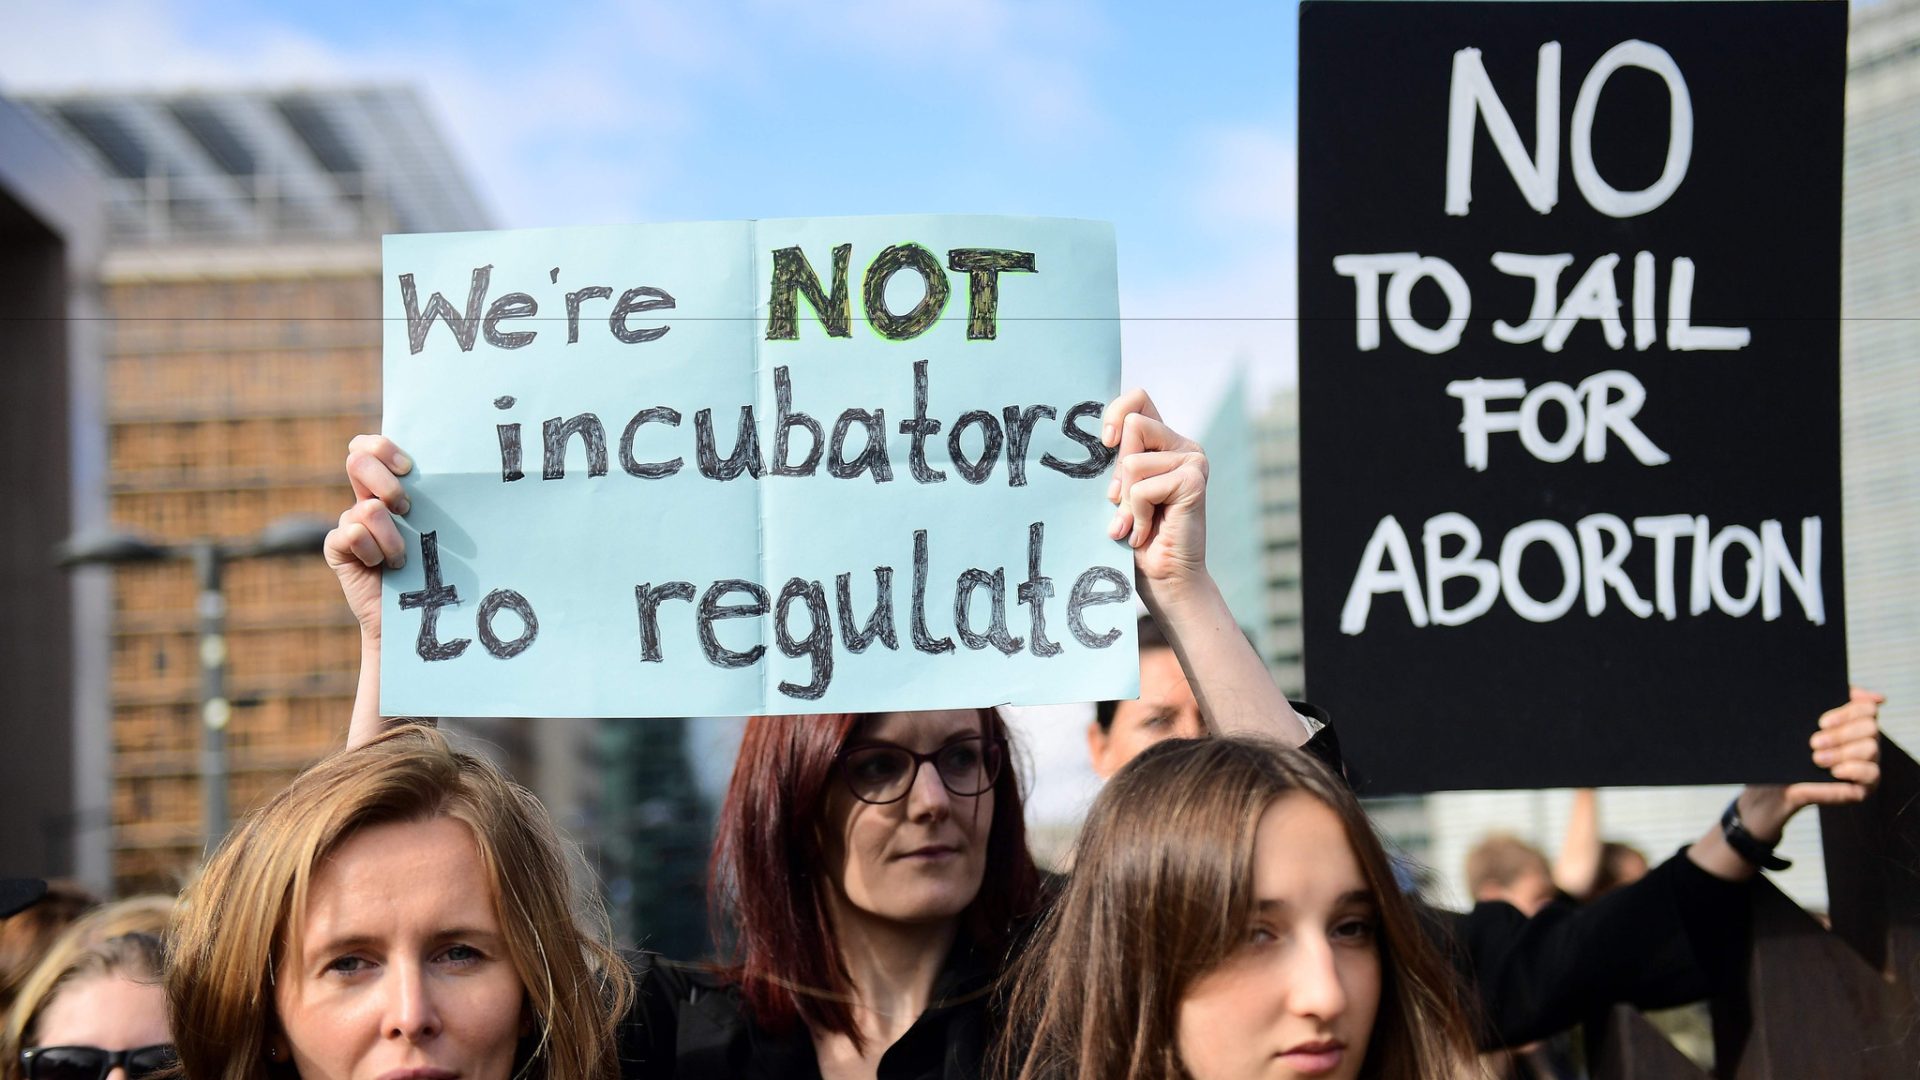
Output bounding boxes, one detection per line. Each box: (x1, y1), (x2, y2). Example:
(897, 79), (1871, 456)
(324, 434), (413, 748)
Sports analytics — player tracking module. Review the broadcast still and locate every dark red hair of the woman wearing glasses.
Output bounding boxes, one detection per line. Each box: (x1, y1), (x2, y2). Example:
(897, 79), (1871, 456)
(707, 709), (1041, 1045)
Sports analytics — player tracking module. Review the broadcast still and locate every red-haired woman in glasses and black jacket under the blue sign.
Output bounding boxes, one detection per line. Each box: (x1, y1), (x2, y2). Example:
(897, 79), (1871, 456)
(628, 709), (1041, 1078)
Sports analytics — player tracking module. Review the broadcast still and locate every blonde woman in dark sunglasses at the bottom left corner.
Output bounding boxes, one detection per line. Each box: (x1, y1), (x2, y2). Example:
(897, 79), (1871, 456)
(6, 934), (175, 1080)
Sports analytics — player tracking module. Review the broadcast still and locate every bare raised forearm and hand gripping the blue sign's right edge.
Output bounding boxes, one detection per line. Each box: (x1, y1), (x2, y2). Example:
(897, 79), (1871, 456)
(1100, 390), (1309, 746)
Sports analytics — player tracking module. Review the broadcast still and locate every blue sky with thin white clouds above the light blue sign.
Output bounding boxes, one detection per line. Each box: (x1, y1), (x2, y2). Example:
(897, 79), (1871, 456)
(0, 0), (1296, 430)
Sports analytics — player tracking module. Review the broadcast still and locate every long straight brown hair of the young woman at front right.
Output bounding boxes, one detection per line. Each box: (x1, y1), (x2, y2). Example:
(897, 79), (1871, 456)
(995, 736), (1475, 1080)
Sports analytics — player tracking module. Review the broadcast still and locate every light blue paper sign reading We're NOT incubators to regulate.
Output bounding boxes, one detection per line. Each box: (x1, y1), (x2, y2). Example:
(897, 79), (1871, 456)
(380, 217), (1139, 717)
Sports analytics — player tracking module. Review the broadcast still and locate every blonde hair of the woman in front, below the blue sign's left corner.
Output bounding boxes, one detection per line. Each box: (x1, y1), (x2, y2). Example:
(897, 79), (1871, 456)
(165, 724), (634, 1080)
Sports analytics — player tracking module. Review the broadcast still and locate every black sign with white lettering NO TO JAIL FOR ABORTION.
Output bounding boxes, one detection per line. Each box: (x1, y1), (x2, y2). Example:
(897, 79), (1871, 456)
(1300, 2), (1847, 792)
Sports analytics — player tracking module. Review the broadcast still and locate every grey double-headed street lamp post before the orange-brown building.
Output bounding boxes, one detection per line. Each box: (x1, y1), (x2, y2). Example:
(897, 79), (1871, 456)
(58, 515), (328, 847)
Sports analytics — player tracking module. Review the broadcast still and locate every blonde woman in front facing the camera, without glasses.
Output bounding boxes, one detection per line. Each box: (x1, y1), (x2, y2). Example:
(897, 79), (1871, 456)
(166, 724), (632, 1080)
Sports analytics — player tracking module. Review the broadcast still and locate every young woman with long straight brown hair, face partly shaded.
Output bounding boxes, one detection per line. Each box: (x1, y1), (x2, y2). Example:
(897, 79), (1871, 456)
(996, 738), (1473, 1080)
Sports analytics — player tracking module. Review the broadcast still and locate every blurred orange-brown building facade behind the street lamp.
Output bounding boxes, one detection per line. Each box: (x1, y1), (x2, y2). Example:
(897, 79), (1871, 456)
(102, 247), (380, 892)
